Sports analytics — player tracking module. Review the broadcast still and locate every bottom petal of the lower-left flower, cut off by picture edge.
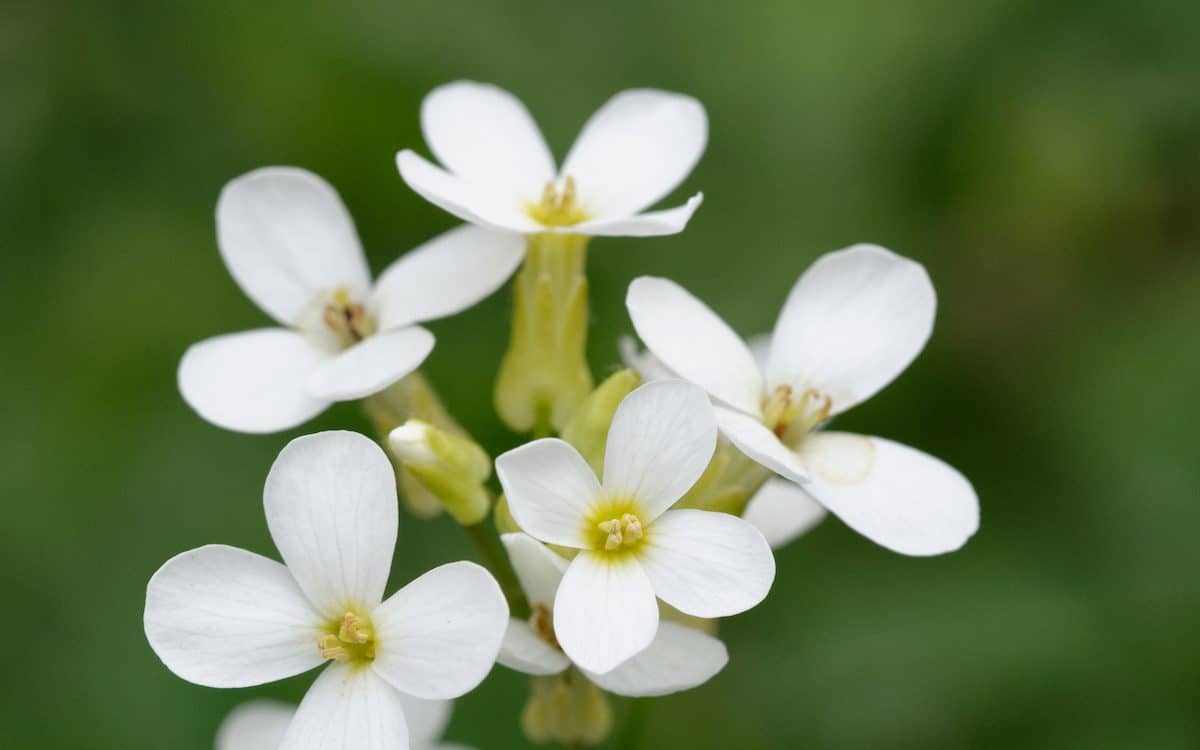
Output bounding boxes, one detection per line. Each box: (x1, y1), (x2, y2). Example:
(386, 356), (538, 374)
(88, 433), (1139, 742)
(280, 664), (409, 750)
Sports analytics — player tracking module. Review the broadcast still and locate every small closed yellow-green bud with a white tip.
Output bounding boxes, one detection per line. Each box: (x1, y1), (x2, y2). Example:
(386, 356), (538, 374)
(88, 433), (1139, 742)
(388, 419), (492, 526)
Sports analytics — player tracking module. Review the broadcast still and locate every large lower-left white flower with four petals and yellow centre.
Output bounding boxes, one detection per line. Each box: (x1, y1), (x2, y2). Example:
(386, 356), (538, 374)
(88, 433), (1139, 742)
(145, 432), (509, 750)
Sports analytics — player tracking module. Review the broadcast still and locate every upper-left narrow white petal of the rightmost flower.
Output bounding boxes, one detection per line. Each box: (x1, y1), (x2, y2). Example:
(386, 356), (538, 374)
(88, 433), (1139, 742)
(625, 276), (762, 414)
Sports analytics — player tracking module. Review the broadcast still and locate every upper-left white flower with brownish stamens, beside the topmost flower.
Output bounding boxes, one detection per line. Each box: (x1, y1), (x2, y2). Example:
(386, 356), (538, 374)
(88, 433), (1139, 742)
(179, 167), (524, 432)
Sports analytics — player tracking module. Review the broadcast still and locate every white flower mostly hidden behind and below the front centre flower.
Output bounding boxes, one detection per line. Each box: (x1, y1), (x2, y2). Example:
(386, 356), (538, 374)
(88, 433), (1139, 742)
(497, 534), (730, 697)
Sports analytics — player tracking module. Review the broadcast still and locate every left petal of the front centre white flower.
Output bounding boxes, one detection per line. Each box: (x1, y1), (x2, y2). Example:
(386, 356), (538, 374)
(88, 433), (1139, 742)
(496, 438), (600, 547)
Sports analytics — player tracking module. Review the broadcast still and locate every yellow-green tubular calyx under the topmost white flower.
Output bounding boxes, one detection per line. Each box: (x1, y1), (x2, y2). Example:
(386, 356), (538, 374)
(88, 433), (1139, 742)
(494, 233), (592, 436)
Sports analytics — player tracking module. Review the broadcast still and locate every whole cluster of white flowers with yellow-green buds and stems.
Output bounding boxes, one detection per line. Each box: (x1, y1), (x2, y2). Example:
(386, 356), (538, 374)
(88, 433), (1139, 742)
(145, 82), (978, 750)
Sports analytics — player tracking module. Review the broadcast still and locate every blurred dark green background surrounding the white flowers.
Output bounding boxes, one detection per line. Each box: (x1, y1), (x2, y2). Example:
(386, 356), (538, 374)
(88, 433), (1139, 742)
(0, 0), (1200, 750)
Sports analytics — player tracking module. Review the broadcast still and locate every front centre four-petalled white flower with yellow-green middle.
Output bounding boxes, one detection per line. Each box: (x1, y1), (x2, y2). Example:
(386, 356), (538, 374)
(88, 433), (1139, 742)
(496, 380), (775, 674)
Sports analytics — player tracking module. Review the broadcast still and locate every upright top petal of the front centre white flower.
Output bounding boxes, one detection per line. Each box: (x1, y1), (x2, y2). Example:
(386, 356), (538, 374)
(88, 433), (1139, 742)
(604, 380), (716, 522)
